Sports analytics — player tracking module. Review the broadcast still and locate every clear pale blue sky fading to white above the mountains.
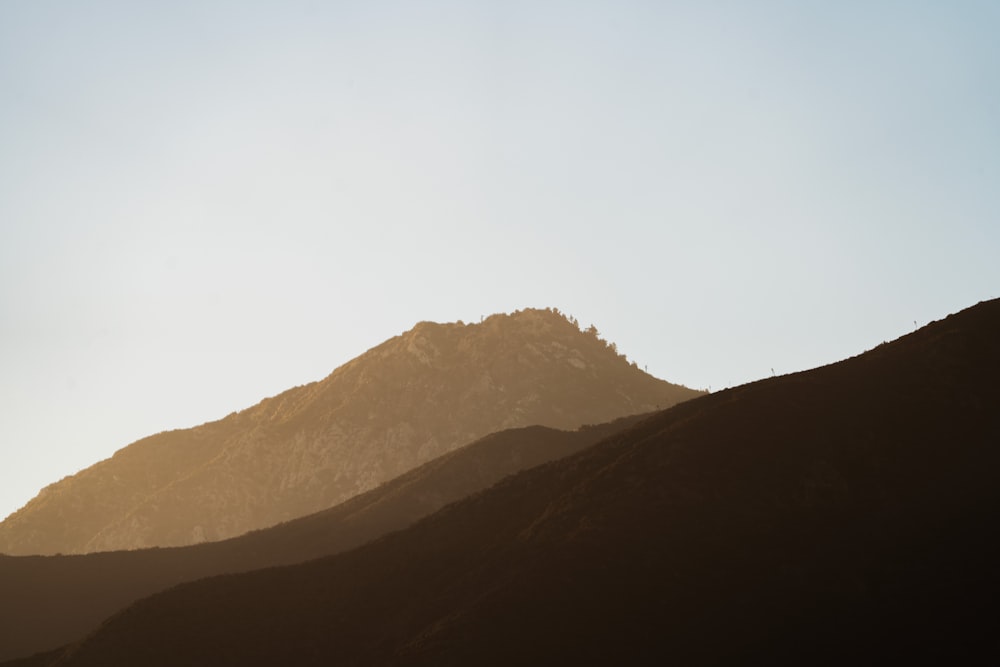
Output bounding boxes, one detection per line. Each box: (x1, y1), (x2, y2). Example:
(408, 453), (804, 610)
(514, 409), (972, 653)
(0, 0), (1000, 517)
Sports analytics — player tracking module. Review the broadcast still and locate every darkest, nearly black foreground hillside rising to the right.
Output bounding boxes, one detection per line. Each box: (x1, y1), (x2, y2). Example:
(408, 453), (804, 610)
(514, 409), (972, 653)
(29, 301), (1000, 667)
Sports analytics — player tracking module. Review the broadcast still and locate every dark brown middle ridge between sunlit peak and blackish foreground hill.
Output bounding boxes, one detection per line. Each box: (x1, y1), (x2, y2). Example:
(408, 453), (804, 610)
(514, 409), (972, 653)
(0, 416), (641, 660)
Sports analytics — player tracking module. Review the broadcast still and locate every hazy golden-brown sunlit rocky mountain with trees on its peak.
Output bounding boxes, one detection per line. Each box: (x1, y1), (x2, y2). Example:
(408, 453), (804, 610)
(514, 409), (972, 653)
(0, 310), (698, 555)
